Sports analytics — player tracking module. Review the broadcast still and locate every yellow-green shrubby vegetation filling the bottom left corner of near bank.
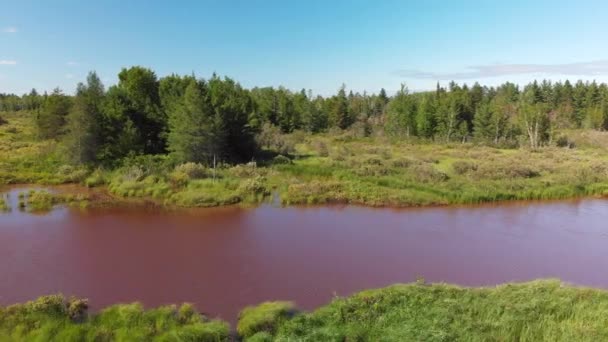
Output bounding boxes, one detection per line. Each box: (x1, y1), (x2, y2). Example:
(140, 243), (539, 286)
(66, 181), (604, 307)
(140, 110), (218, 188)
(0, 295), (229, 342)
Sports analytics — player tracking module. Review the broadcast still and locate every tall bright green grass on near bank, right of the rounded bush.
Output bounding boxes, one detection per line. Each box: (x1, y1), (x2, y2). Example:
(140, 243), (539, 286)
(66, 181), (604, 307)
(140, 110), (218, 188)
(270, 280), (608, 341)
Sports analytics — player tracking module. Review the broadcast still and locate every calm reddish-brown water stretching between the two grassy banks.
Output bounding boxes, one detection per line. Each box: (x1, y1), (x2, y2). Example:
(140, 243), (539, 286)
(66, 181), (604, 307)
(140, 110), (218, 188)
(0, 188), (608, 321)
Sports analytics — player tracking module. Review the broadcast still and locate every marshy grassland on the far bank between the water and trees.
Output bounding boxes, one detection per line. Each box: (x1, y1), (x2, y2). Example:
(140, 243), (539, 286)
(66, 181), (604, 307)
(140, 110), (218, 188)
(0, 113), (608, 207)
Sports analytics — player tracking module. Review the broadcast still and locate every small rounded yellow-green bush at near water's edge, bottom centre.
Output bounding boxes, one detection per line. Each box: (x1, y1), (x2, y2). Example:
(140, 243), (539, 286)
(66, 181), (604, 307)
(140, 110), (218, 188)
(236, 302), (296, 338)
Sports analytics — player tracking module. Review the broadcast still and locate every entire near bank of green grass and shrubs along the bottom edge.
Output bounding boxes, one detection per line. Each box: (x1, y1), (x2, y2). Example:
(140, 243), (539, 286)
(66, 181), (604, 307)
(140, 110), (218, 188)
(0, 280), (608, 341)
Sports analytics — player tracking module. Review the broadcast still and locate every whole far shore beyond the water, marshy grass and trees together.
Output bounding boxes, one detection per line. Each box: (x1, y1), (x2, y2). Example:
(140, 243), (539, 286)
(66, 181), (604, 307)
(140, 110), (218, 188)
(0, 66), (608, 206)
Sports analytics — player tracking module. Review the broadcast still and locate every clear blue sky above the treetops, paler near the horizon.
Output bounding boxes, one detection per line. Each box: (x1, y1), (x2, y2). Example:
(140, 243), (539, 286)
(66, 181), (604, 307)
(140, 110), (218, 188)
(0, 0), (608, 95)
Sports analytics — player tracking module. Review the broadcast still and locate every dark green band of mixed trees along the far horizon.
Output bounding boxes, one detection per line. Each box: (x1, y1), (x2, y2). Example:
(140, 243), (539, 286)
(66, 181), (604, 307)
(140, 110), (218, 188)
(0, 66), (608, 164)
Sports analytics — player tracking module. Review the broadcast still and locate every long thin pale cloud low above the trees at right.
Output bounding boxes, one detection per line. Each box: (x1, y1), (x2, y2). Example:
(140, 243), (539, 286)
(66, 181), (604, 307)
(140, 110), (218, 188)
(393, 59), (608, 80)
